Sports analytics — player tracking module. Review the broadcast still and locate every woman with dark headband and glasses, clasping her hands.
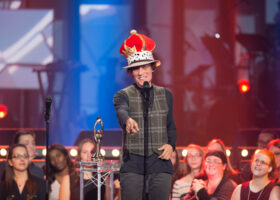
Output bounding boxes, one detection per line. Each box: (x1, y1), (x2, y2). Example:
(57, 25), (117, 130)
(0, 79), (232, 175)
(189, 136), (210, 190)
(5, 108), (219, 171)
(184, 150), (236, 200)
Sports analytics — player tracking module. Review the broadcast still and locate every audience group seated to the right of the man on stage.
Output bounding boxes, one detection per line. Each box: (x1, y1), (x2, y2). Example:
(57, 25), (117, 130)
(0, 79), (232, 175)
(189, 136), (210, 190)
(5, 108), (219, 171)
(170, 130), (280, 200)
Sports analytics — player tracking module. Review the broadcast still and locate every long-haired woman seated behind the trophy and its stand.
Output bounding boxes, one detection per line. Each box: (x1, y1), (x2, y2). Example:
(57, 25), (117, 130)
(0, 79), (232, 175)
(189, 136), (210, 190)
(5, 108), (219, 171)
(59, 139), (105, 200)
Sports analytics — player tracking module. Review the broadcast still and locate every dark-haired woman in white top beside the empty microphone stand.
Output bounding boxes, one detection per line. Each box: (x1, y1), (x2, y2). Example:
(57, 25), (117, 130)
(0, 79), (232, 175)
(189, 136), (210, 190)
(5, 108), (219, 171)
(48, 144), (75, 200)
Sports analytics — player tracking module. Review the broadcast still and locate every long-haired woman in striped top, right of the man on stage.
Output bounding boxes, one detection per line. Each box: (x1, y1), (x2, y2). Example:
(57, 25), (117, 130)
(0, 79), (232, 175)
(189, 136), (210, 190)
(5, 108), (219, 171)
(172, 144), (203, 200)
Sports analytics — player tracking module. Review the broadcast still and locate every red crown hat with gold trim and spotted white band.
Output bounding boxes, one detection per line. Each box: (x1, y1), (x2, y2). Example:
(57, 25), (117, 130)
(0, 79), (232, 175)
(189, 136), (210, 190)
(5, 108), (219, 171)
(120, 30), (160, 69)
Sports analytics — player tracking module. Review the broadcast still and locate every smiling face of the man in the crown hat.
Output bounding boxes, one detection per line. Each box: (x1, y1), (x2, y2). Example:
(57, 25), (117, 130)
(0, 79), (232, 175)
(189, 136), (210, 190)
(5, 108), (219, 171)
(132, 64), (153, 88)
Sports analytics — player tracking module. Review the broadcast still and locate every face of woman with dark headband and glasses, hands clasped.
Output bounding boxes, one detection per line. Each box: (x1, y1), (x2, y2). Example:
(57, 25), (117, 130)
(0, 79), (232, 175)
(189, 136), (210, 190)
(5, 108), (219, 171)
(205, 156), (226, 177)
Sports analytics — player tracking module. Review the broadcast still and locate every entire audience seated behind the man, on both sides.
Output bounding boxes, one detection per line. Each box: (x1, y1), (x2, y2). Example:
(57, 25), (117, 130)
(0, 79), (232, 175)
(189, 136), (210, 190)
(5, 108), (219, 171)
(0, 130), (280, 200)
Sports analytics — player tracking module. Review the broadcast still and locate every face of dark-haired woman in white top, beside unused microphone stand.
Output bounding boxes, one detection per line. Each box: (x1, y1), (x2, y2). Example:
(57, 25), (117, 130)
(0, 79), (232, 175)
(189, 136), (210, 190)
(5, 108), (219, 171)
(49, 149), (67, 172)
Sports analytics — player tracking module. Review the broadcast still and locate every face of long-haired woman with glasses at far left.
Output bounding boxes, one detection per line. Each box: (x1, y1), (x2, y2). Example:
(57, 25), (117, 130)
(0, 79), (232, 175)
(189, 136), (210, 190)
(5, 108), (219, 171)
(8, 147), (29, 171)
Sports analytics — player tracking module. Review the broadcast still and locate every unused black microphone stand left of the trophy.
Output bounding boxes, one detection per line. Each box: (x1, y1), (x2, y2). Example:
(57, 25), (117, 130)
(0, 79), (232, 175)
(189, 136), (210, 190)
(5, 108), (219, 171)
(45, 96), (52, 200)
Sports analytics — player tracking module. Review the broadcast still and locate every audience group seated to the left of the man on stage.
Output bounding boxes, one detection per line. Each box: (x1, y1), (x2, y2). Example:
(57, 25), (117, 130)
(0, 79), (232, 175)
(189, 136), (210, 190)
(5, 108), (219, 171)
(0, 131), (110, 200)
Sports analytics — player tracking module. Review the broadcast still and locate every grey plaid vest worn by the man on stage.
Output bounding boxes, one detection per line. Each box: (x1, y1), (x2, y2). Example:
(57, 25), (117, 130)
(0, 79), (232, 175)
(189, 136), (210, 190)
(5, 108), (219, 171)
(123, 85), (168, 156)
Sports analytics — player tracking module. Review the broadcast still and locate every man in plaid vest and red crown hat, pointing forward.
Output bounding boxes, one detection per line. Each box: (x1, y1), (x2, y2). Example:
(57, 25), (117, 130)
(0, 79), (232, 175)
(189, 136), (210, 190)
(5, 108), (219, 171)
(113, 30), (177, 200)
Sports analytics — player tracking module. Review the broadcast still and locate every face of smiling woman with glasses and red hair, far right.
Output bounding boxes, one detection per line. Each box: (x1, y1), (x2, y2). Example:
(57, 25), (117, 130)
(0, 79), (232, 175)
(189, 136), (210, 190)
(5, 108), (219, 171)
(251, 152), (272, 177)
